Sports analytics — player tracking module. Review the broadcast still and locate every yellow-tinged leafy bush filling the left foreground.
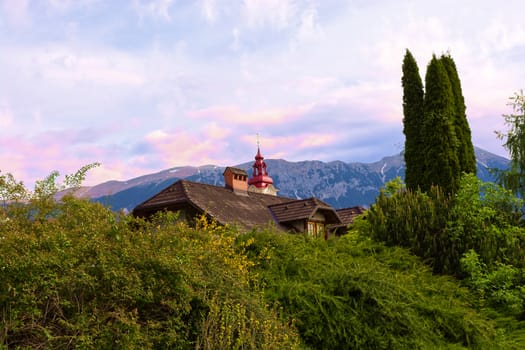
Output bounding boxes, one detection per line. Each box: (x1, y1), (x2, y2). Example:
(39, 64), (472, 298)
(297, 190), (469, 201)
(0, 197), (298, 349)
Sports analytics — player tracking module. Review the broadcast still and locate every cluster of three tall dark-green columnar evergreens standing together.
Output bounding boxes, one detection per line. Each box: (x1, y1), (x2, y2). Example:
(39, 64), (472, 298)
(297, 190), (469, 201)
(402, 50), (476, 194)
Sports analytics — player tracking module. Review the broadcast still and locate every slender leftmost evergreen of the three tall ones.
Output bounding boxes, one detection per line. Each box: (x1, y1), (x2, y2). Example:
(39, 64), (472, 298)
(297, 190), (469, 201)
(401, 49), (424, 190)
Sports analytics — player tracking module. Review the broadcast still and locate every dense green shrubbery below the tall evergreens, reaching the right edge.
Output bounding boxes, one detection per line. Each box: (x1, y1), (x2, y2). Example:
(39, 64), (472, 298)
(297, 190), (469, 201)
(361, 175), (525, 341)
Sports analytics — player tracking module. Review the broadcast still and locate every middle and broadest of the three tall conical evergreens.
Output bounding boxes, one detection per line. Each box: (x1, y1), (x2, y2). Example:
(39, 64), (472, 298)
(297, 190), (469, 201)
(420, 55), (461, 193)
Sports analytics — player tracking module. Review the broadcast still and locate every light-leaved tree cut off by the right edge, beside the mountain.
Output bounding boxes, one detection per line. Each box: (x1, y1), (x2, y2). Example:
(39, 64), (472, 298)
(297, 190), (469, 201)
(496, 91), (525, 198)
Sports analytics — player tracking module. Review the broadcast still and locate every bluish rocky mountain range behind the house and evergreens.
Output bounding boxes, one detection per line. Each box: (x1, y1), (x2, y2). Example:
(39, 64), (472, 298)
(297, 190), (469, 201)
(90, 148), (508, 211)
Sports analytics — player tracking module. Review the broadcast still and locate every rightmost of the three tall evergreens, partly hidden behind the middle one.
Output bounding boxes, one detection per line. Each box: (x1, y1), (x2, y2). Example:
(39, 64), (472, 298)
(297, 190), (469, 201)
(440, 54), (476, 174)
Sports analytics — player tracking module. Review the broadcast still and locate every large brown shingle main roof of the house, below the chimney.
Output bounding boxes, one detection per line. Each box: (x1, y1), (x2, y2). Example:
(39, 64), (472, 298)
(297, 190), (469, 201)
(133, 180), (293, 229)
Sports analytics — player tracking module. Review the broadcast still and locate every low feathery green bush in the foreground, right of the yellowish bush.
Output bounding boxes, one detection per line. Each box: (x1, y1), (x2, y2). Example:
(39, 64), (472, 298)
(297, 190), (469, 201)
(238, 232), (519, 349)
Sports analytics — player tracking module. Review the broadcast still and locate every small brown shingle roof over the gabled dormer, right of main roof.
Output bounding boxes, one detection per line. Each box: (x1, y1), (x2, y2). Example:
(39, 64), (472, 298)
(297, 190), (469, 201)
(268, 198), (341, 224)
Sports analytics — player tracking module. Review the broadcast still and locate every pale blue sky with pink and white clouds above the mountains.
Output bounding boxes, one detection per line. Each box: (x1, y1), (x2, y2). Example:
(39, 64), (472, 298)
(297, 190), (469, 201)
(0, 0), (525, 186)
